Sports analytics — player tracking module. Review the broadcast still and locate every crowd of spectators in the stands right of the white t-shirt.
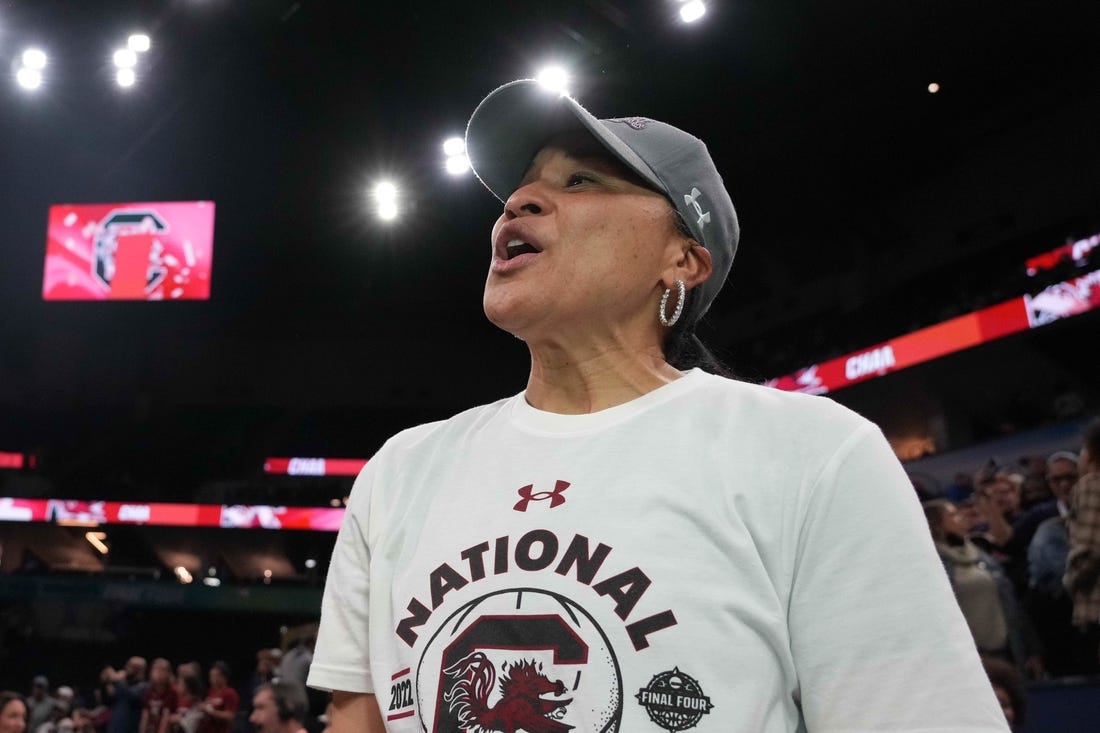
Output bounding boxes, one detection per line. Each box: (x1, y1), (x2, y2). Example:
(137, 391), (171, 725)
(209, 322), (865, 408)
(917, 418), (1100, 717)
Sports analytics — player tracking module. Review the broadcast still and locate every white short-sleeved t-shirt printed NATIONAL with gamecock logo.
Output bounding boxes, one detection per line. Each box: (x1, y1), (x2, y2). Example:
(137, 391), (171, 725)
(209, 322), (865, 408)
(309, 370), (1008, 733)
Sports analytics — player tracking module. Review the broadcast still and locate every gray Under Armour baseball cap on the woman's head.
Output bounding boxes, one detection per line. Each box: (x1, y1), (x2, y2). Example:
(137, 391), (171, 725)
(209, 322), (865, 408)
(466, 79), (740, 324)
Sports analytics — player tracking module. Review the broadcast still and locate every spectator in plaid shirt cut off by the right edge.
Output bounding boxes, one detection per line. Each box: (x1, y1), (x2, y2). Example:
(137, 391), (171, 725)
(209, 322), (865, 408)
(1063, 417), (1100, 674)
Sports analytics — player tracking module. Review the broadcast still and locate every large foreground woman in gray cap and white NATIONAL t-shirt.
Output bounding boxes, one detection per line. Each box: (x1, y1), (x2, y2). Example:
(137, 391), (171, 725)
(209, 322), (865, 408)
(309, 80), (1004, 733)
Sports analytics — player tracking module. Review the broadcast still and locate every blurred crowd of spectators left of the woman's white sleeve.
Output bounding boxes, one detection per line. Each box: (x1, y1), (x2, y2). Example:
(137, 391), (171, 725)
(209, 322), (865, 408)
(0, 620), (328, 733)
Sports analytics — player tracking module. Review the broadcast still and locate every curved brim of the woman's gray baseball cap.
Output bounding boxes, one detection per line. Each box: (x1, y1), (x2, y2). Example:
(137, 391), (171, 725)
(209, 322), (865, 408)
(466, 79), (668, 201)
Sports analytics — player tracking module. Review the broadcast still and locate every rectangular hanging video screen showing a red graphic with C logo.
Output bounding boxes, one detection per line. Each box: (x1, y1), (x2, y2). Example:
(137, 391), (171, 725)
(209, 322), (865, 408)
(42, 201), (215, 300)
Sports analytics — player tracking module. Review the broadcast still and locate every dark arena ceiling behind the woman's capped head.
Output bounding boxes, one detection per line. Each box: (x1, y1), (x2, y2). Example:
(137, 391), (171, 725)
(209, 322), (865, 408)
(0, 0), (1100, 502)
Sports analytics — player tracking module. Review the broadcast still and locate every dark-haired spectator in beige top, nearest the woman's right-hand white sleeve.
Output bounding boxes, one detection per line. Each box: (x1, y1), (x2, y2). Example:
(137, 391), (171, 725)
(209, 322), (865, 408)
(923, 499), (1043, 677)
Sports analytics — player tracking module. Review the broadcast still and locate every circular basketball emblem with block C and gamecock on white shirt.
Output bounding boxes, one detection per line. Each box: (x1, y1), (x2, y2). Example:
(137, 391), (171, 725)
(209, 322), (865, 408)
(416, 588), (623, 733)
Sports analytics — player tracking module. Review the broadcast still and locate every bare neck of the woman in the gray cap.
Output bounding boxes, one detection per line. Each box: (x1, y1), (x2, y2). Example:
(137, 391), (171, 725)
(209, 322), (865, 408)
(526, 330), (683, 415)
